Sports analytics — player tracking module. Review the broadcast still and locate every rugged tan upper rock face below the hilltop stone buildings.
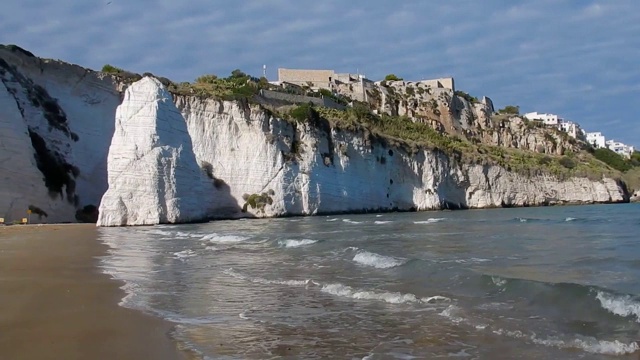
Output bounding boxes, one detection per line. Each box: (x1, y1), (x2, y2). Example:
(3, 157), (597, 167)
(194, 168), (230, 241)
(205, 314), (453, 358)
(368, 81), (580, 155)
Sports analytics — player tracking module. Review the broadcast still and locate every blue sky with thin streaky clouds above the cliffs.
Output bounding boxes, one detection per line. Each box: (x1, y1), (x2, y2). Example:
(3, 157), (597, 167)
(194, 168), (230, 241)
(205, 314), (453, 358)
(0, 0), (640, 146)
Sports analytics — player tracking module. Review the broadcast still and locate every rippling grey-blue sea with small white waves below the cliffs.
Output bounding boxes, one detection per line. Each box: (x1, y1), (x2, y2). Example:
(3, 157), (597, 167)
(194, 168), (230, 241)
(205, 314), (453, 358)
(99, 204), (640, 359)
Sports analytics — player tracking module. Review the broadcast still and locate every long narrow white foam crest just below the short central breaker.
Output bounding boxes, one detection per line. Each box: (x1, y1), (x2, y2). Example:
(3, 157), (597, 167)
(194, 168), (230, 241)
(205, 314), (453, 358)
(320, 284), (451, 304)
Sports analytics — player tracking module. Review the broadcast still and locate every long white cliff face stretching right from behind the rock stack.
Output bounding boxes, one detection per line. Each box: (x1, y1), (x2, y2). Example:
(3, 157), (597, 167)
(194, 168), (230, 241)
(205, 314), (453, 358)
(176, 97), (624, 216)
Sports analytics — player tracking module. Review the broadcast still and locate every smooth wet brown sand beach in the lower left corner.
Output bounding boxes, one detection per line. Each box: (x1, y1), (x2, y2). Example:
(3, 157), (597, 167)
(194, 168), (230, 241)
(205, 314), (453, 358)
(0, 225), (192, 360)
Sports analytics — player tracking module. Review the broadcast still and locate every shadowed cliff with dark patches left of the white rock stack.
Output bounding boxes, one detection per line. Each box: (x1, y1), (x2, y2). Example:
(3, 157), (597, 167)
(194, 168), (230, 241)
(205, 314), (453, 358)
(0, 49), (120, 222)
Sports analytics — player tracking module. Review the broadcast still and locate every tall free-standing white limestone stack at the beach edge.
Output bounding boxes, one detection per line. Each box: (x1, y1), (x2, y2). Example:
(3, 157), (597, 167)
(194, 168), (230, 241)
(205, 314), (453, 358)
(98, 77), (214, 226)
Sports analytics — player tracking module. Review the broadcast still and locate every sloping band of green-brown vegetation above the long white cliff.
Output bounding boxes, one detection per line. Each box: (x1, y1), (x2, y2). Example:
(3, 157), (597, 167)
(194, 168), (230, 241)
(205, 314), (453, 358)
(281, 103), (620, 180)
